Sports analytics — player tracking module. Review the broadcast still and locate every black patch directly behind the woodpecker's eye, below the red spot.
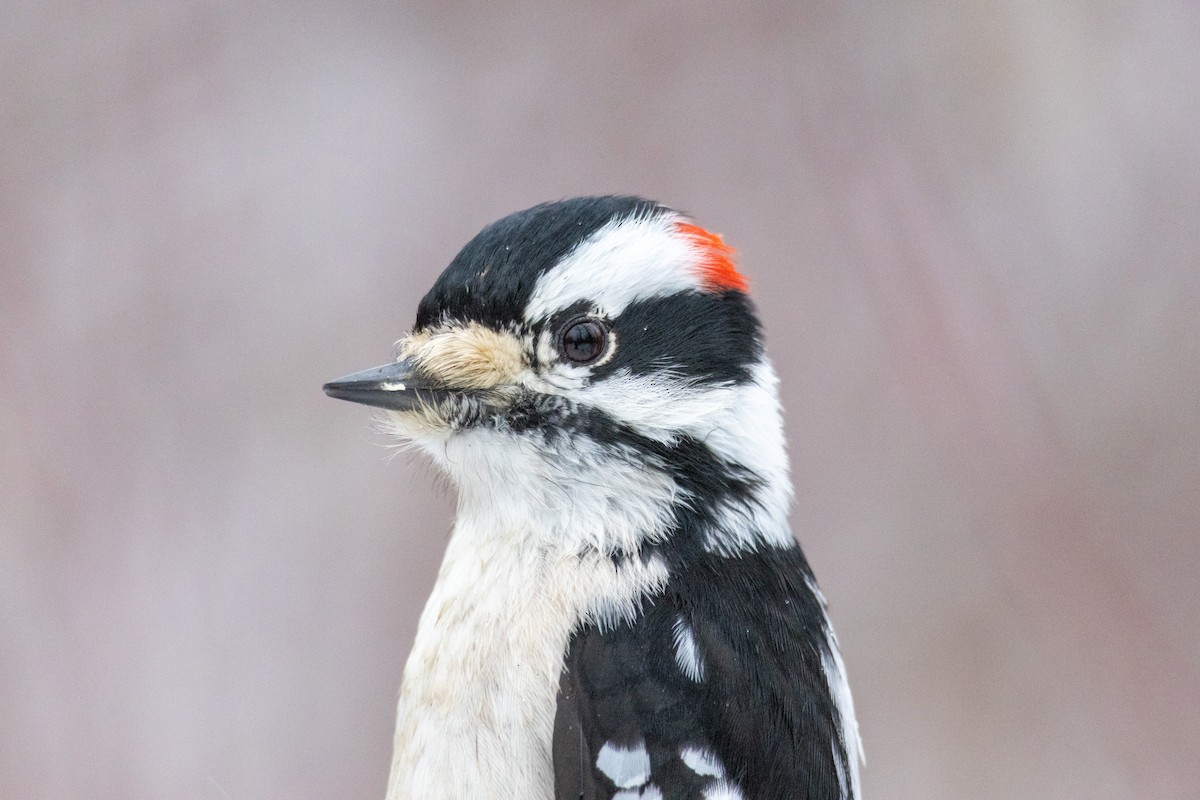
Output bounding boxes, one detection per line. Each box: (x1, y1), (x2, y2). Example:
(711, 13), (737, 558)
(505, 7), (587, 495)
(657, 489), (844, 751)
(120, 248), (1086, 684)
(604, 291), (762, 383)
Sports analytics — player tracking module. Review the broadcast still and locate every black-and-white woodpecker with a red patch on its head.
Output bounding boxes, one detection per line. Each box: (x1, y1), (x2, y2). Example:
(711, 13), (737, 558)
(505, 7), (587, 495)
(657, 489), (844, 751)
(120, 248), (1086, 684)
(324, 197), (862, 800)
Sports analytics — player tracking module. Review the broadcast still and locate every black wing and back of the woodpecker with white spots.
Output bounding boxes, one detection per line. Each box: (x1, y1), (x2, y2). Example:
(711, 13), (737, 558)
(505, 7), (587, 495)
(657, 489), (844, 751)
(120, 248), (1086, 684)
(553, 547), (857, 800)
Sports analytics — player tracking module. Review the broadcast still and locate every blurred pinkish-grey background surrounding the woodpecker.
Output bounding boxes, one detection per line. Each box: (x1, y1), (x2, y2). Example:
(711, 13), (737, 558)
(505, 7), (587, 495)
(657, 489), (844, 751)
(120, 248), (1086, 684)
(0, 0), (1200, 800)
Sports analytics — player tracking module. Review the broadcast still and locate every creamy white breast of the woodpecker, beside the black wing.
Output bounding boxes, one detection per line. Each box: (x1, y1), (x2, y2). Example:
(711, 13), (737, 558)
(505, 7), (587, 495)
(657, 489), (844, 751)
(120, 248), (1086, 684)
(388, 516), (666, 800)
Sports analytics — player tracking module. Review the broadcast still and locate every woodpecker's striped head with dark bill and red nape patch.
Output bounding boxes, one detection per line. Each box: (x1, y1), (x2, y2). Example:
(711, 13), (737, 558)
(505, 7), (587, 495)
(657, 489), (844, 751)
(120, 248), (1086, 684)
(325, 197), (791, 552)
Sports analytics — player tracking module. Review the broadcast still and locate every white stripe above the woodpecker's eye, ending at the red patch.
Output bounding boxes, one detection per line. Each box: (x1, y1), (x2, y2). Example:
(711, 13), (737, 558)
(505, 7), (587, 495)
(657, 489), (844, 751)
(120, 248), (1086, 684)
(526, 212), (702, 323)
